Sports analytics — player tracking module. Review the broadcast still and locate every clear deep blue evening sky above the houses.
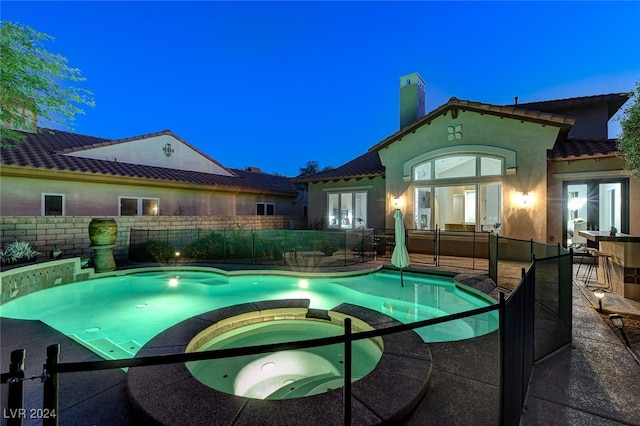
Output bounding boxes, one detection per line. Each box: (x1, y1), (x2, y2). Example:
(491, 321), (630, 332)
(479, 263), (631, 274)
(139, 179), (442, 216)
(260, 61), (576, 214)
(5, 1), (640, 176)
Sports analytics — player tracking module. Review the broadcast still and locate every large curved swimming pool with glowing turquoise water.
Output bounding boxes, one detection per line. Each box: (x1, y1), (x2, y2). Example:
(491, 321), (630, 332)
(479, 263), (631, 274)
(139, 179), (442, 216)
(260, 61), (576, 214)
(0, 268), (498, 359)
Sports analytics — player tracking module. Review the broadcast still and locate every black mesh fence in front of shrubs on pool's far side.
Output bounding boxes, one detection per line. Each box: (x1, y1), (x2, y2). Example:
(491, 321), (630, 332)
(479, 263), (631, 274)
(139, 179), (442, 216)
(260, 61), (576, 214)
(129, 229), (376, 267)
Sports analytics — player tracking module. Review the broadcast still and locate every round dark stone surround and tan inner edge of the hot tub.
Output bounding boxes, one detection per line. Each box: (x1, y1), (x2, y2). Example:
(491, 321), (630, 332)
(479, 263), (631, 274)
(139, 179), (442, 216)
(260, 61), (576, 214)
(127, 299), (431, 425)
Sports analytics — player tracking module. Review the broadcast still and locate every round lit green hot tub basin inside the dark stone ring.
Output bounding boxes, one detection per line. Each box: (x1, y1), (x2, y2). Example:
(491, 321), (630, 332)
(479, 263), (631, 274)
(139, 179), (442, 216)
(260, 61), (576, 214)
(186, 310), (382, 399)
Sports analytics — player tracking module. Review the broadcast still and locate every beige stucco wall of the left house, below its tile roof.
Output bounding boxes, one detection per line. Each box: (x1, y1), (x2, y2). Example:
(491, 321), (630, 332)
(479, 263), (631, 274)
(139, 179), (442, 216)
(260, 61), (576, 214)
(0, 175), (302, 216)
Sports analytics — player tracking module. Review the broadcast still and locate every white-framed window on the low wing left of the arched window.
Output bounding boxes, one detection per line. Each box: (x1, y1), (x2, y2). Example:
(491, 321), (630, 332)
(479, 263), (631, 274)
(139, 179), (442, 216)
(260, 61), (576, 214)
(327, 192), (367, 229)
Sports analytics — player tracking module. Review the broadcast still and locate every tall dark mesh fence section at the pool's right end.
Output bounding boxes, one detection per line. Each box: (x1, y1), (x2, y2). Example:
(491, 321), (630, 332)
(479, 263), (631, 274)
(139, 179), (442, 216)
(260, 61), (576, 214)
(498, 236), (573, 425)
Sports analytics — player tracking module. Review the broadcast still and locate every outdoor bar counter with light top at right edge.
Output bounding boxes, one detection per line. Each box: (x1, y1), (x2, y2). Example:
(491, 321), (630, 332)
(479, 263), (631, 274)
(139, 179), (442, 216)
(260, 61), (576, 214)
(578, 231), (640, 301)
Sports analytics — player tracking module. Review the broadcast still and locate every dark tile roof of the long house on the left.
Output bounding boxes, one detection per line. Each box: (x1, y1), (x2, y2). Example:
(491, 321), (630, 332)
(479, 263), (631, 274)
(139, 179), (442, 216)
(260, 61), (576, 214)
(0, 129), (297, 195)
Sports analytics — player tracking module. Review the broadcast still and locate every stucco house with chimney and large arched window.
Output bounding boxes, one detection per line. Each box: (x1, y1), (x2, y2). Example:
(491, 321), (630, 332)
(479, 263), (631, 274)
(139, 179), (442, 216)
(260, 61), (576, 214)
(295, 73), (640, 246)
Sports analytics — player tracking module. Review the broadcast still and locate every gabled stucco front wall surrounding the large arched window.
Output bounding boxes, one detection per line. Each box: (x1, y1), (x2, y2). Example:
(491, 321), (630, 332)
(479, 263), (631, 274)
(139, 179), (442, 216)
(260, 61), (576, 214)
(380, 111), (558, 241)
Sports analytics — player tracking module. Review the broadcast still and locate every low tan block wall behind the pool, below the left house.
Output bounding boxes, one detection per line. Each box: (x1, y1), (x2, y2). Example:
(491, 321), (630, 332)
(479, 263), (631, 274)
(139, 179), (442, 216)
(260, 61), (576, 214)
(0, 216), (307, 259)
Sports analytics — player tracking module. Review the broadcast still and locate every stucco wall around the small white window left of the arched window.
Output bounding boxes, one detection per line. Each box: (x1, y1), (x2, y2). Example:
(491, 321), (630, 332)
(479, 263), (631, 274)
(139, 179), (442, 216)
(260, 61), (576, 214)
(308, 177), (386, 228)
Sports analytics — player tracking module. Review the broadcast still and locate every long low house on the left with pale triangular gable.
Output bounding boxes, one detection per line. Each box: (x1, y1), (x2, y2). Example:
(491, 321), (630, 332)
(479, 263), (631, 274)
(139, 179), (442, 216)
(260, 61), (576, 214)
(0, 129), (305, 216)
